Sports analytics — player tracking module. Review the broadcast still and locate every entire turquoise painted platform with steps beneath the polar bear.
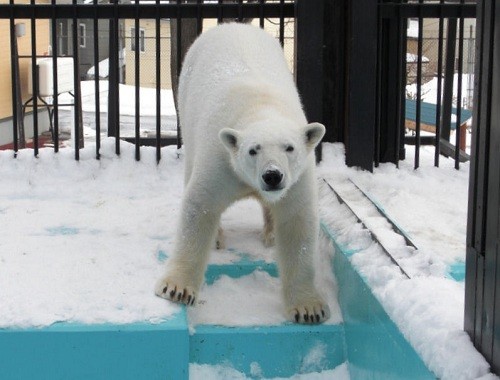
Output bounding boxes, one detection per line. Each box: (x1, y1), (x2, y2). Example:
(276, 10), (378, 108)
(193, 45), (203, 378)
(0, 226), (435, 380)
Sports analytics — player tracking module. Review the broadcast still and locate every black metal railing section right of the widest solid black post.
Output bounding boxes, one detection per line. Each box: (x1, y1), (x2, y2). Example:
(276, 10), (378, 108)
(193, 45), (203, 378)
(375, 0), (476, 169)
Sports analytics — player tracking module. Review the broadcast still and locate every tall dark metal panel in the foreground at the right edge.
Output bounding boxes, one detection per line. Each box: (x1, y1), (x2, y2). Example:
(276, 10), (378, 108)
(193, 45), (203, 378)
(464, 0), (500, 373)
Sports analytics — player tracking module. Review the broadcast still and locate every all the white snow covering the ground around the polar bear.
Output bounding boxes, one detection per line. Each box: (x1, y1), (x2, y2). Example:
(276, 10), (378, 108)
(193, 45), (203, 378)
(0, 82), (496, 380)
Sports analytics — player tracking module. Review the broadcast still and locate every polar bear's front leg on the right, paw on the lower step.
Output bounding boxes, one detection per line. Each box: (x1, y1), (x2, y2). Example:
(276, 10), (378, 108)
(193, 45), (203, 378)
(275, 176), (330, 323)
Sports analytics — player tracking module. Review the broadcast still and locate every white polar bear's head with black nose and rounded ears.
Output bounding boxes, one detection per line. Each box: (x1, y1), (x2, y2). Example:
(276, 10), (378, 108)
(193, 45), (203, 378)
(219, 123), (325, 203)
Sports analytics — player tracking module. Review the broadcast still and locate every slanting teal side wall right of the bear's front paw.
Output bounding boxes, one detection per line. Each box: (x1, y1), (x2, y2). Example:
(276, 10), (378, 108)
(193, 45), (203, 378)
(321, 224), (436, 380)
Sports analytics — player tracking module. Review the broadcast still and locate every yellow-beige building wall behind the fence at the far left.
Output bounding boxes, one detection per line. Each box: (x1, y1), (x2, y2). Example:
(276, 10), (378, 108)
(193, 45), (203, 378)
(0, 5), (49, 119)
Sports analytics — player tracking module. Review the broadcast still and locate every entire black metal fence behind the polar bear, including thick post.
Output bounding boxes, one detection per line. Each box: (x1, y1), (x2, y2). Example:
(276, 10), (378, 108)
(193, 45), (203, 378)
(0, 0), (476, 170)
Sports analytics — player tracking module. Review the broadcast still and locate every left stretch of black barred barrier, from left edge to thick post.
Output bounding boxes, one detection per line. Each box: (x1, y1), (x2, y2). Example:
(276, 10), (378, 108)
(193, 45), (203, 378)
(0, 0), (294, 160)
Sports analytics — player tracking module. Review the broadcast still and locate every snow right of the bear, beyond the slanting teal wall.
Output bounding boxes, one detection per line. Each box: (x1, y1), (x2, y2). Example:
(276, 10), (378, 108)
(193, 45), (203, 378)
(320, 145), (489, 379)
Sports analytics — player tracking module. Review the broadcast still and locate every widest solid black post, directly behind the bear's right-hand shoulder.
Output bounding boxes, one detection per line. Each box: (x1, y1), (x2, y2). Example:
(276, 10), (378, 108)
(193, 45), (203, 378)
(295, 0), (377, 171)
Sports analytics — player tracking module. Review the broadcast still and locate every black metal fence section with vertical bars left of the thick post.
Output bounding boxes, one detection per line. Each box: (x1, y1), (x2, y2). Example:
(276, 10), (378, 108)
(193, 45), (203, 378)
(0, 0), (295, 160)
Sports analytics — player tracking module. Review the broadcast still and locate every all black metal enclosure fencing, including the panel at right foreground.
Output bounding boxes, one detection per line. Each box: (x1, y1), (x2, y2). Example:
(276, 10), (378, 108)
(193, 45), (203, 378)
(4, 0), (500, 378)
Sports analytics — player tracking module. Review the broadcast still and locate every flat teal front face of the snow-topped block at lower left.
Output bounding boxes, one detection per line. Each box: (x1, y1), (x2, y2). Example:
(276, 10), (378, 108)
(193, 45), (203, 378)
(0, 310), (189, 380)
